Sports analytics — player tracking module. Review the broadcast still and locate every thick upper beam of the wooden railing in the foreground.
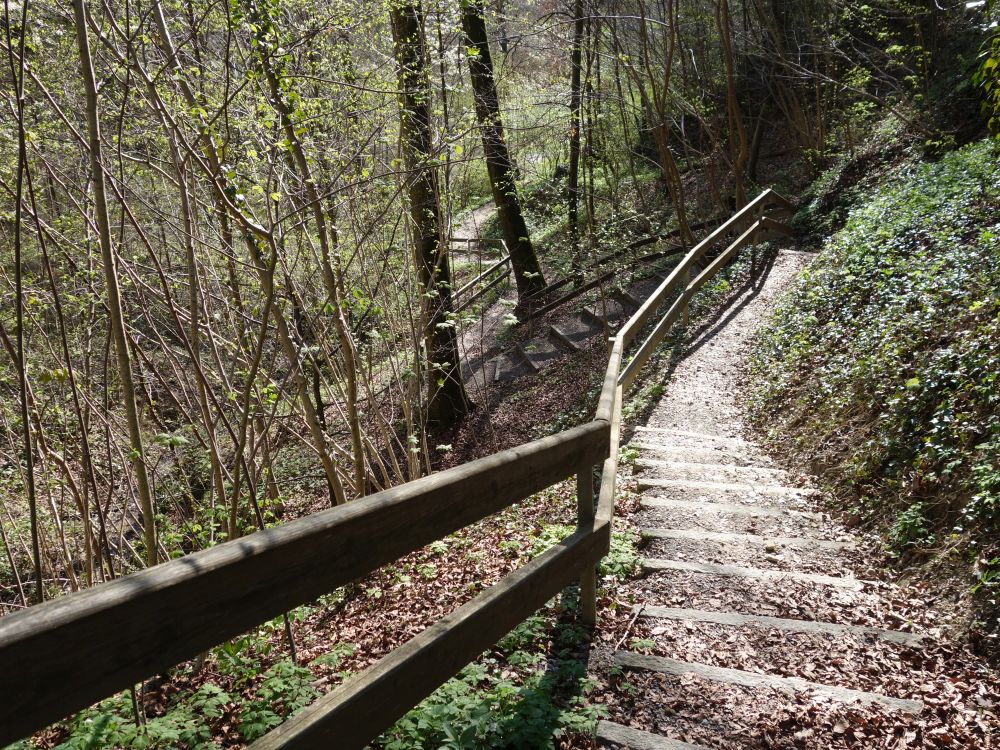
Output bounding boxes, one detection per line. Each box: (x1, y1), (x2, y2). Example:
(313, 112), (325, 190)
(0, 422), (609, 747)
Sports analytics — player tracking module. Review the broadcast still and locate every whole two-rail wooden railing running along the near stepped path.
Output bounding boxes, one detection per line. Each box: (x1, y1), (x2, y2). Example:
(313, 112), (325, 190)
(0, 190), (790, 750)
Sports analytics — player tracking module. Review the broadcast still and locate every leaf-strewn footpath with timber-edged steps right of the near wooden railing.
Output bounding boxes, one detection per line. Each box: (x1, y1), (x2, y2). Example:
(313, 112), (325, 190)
(591, 250), (998, 750)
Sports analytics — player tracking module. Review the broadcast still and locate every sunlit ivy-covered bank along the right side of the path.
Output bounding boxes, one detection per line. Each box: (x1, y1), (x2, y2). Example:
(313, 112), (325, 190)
(748, 141), (1000, 629)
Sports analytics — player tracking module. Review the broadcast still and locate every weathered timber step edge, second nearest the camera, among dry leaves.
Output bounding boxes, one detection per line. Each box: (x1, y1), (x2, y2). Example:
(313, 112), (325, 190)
(615, 651), (924, 714)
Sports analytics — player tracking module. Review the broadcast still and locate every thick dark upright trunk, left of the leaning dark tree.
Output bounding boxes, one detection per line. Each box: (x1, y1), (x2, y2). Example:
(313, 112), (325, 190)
(389, 0), (469, 426)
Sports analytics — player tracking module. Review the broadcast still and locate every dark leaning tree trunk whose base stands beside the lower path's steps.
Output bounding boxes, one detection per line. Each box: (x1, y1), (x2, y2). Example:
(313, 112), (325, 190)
(462, 0), (545, 307)
